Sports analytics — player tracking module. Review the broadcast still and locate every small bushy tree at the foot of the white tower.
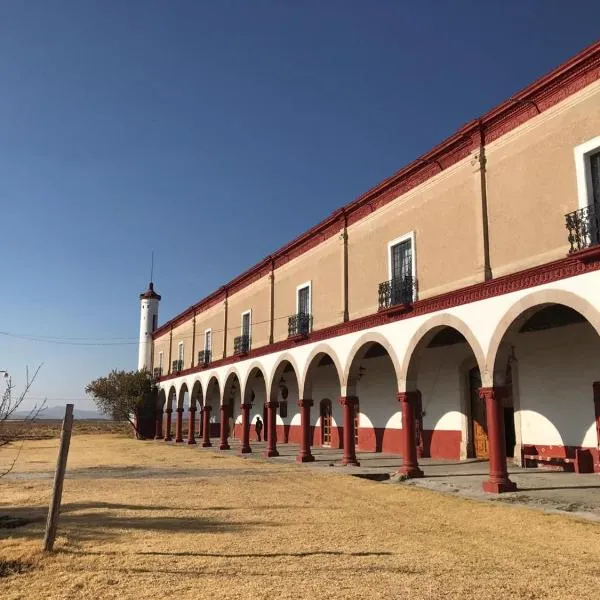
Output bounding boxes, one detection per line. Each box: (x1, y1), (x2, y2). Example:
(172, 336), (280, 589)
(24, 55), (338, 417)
(85, 369), (156, 439)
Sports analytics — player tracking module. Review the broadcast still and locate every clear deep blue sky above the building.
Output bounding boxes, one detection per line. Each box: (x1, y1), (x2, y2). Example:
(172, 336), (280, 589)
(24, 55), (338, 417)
(0, 0), (600, 407)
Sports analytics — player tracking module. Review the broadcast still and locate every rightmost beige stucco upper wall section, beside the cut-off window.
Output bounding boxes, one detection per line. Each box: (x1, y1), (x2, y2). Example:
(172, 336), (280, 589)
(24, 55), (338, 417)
(486, 82), (600, 277)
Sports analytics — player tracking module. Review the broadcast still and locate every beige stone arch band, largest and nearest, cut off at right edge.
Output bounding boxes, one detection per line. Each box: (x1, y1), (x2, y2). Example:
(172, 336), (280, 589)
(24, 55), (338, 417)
(484, 289), (600, 385)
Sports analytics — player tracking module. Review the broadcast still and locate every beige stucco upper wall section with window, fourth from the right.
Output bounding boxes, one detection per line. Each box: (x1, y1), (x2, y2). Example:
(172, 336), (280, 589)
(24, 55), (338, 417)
(227, 276), (271, 356)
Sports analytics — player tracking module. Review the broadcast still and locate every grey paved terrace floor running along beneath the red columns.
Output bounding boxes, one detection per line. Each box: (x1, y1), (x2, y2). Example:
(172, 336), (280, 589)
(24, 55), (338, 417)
(186, 438), (600, 521)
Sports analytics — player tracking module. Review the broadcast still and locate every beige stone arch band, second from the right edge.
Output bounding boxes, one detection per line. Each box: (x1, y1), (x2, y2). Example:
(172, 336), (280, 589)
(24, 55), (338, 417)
(398, 313), (487, 391)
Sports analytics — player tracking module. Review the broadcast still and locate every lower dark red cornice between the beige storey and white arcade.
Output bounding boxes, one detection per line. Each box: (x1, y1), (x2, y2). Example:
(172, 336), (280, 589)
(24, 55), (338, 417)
(160, 254), (600, 381)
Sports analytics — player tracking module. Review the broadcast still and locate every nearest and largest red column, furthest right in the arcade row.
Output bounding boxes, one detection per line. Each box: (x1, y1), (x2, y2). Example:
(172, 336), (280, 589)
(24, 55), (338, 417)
(479, 387), (517, 494)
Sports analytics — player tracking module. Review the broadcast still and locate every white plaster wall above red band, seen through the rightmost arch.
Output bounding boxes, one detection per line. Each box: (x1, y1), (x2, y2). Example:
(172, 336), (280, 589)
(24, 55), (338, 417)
(515, 324), (600, 448)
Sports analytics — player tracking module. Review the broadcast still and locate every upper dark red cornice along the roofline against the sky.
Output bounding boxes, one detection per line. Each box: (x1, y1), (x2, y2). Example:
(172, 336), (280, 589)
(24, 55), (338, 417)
(153, 41), (600, 338)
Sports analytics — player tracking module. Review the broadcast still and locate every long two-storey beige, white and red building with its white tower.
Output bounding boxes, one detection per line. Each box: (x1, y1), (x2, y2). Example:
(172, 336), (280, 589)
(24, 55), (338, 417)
(139, 42), (600, 492)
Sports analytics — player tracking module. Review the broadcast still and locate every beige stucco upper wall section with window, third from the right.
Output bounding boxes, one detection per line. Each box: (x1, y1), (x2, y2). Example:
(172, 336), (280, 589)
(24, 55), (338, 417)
(274, 235), (344, 342)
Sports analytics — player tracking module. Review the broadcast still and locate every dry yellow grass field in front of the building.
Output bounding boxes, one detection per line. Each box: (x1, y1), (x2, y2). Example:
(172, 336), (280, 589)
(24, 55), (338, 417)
(0, 434), (600, 600)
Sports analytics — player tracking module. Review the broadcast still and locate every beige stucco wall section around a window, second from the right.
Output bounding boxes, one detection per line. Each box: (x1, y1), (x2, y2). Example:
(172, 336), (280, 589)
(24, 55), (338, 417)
(348, 158), (483, 319)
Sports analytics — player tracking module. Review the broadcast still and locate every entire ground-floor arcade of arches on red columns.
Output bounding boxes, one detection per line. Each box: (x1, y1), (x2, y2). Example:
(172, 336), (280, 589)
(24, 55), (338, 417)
(155, 303), (600, 492)
